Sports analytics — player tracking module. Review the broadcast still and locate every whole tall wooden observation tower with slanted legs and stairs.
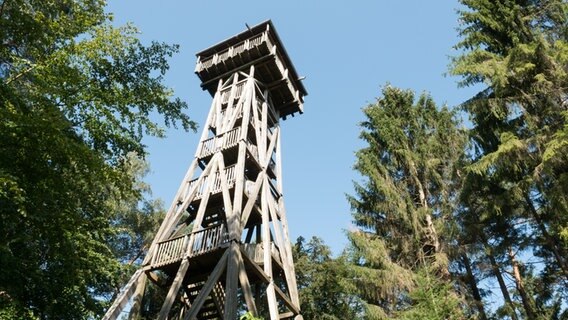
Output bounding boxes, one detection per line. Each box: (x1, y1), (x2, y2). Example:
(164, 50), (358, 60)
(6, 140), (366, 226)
(104, 21), (307, 320)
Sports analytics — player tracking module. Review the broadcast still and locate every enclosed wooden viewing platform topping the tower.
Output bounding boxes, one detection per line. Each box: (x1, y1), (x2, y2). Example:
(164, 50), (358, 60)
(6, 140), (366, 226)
(195, 20), (308, 117)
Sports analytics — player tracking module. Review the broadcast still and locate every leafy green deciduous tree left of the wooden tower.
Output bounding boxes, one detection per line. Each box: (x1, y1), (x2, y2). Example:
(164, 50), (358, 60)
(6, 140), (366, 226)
(0, 0), (195, 319)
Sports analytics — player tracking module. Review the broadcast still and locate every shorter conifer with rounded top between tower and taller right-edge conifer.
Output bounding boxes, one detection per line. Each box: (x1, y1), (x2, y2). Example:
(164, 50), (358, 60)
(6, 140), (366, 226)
(348, 85), (465, 319)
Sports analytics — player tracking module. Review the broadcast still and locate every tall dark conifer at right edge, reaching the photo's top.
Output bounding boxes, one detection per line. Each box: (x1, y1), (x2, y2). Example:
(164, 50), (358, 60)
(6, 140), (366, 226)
(451, 0), (568, 318)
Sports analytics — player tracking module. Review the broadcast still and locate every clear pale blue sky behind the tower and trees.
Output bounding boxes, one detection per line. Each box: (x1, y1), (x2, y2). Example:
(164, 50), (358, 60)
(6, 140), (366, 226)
(108, 0), (480, 254)
